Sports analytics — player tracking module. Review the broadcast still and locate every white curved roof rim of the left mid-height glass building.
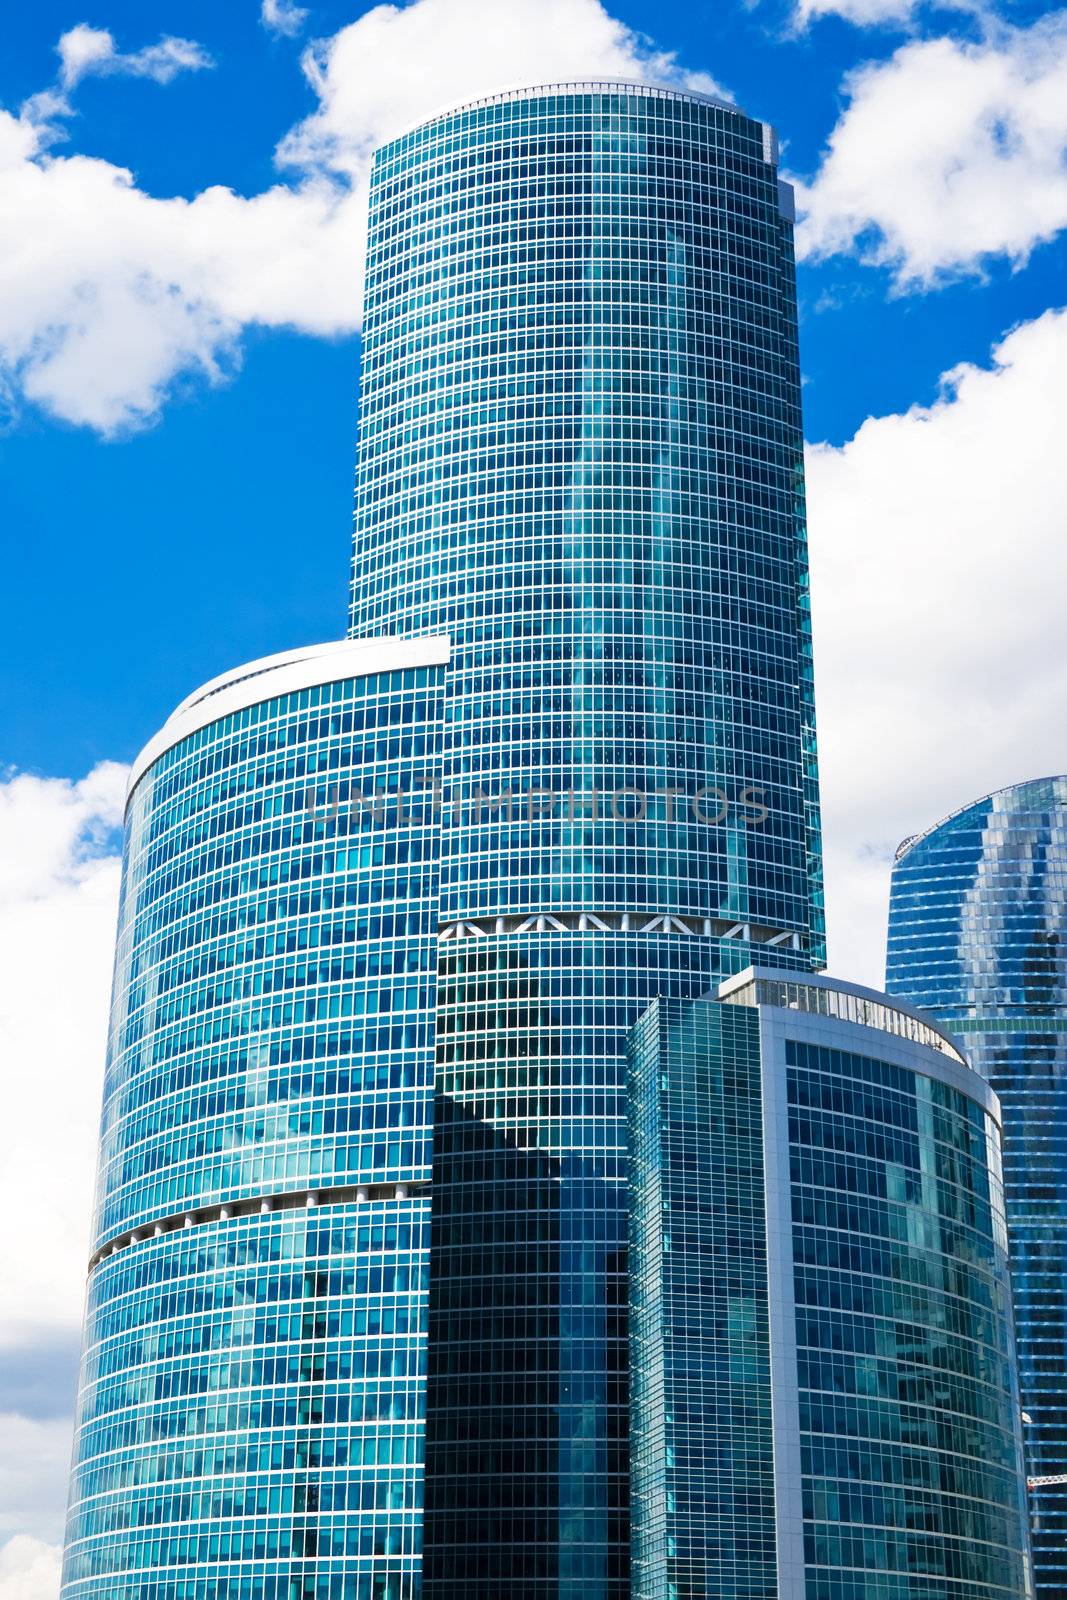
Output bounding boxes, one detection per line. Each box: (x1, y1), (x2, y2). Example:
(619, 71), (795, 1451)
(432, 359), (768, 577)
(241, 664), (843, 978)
(126, 634), (451, 802)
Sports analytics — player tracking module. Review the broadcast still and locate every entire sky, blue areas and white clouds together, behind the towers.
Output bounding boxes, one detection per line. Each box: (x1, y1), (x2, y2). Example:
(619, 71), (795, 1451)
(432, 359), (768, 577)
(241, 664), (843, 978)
(0, 0), (1067, 1600)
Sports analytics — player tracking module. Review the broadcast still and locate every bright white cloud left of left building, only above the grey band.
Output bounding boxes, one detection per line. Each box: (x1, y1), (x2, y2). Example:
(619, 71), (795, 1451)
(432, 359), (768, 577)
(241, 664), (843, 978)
(0, 763), (125, 1344)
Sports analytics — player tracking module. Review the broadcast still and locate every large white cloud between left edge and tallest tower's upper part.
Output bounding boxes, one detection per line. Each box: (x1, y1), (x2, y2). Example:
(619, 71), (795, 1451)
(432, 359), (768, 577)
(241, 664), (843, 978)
(0, 112), (360, 434)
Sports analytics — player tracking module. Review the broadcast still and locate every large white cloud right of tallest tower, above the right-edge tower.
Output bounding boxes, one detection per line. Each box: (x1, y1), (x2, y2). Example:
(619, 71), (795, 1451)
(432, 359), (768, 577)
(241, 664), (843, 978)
(808, 310), (1067, 982)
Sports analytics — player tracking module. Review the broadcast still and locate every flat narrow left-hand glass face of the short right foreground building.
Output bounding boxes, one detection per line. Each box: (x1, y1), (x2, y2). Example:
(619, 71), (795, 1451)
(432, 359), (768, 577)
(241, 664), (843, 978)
(629, 1000), (779, 1600)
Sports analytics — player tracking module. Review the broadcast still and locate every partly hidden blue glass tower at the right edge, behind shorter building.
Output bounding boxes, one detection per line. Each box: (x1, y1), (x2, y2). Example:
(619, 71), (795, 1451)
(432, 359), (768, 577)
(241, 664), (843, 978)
(886, 778), (1067, 1600)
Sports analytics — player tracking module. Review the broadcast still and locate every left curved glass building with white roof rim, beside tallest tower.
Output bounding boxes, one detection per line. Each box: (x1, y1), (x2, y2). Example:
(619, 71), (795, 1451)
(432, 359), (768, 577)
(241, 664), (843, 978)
(62, 645), (446, 1600)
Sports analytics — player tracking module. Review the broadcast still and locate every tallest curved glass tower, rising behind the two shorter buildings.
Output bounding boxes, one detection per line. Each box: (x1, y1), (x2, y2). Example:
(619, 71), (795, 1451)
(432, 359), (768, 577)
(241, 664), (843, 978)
(352, 83), (822, 1600)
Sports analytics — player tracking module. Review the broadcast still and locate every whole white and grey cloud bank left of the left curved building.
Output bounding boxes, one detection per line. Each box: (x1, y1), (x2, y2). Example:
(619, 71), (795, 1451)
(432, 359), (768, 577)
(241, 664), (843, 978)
(0, 763), (125, 1580)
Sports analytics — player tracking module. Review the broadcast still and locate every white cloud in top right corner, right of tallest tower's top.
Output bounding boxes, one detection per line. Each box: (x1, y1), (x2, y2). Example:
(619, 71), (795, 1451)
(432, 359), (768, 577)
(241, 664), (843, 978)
(798, 11), (1067, 288)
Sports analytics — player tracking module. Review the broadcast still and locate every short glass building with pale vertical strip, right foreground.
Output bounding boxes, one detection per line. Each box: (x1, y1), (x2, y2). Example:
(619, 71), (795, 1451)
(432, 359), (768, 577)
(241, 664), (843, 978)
(629, 968), (1033, 1600)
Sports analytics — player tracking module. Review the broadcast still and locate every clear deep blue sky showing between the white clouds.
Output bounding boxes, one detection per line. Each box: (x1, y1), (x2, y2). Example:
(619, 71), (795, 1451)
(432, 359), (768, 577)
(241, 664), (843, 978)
(0, 0), (1065, 774)
